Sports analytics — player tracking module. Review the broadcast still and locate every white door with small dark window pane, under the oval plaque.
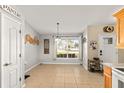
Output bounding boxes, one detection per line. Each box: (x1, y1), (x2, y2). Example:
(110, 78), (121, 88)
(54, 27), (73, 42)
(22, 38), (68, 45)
(99, 36), (117, 63)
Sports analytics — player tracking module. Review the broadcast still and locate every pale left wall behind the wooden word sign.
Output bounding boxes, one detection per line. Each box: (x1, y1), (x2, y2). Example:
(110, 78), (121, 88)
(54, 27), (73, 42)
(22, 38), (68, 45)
(24, 22), (40, 72)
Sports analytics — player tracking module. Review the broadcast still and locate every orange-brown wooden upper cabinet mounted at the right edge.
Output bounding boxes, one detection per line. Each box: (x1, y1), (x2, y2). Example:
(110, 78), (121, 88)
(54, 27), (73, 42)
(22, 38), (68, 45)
(113, 9), (124, 49)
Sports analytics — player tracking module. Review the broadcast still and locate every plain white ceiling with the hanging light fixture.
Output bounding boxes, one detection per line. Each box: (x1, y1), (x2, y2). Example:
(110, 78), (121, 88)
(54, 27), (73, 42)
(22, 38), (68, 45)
(16, 5), (124, 34)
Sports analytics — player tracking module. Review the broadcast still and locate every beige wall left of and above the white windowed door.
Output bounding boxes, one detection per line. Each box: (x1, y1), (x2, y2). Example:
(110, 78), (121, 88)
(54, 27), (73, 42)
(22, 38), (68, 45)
(87, 24), (115, 59)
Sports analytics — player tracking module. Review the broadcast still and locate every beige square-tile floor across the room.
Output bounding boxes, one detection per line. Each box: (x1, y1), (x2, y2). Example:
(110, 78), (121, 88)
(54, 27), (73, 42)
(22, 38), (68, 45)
(26, 64), (103, 88)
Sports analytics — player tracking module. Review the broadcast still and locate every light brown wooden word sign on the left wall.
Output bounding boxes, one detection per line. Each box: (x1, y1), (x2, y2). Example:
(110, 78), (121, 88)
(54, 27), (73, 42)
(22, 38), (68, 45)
(25, 34), (40, 45)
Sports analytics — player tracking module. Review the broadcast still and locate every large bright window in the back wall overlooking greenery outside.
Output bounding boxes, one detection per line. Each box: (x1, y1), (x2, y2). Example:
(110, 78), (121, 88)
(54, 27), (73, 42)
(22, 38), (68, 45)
(56, 38), (79, 58)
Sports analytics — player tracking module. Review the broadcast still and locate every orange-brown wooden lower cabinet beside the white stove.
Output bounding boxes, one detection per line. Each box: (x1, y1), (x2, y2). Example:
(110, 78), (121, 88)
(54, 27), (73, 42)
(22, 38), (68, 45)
(104, 66), (112, 88)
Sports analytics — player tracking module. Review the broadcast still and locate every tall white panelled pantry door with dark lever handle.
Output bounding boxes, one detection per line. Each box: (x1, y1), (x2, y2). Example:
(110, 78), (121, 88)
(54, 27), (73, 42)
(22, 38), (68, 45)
(2, 15), (21, 88)
